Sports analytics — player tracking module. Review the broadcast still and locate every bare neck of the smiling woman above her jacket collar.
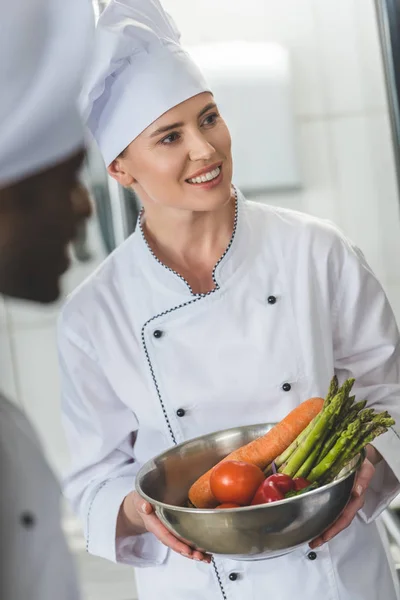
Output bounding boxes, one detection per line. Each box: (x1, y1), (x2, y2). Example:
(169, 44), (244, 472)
(142, 189), (236, 291)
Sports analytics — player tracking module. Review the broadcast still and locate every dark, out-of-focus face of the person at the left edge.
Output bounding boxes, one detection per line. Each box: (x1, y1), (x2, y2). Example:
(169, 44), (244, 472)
(0, 152), (90, 303)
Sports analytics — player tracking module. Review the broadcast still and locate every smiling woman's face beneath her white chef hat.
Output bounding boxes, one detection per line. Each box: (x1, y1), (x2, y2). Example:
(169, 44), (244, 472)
(108, 93), (232, 211)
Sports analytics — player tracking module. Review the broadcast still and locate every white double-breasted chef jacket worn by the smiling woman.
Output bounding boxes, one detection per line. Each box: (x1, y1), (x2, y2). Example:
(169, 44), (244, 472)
(59, 193), (400, 600)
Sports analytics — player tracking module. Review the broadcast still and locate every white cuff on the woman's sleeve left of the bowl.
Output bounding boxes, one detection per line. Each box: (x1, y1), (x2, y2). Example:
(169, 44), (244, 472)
(86, 476), (168, 567)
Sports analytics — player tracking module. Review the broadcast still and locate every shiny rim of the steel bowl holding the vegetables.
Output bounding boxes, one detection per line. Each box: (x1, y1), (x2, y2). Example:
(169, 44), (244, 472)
(135, 422), (366, 515)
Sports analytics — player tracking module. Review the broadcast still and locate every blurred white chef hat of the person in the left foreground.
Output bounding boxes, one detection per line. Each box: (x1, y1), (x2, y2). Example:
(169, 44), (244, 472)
(0, 0), (94, 187)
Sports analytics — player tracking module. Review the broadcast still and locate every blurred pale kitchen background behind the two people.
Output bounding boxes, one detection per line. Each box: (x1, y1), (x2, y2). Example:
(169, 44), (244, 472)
(0, 0), (400, 600)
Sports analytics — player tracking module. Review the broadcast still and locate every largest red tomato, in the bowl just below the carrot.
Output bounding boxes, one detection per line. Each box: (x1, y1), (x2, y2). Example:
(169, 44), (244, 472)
(210, 460), (264, 506)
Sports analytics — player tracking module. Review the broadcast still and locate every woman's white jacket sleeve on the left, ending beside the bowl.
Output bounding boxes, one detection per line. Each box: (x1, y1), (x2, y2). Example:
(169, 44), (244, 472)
(58, 316), (168, 567)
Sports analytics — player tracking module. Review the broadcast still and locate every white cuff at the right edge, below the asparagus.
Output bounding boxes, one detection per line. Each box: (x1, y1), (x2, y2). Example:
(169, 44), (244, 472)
(359, 429), (400, 523)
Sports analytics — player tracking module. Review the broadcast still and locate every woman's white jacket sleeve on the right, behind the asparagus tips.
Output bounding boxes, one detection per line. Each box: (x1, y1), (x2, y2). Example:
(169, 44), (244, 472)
(333, 239), (400, 522)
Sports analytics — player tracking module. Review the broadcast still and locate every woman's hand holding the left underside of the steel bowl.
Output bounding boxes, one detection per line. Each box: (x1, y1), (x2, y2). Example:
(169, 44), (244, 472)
(117, 492), (211, 563)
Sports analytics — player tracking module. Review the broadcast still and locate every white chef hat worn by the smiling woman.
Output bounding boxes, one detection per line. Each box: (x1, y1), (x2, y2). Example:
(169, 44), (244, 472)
(81, 0), (210, 166)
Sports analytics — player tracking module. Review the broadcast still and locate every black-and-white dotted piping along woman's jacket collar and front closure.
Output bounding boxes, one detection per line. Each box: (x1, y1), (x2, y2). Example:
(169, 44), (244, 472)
(138, 188), (239, 600)
